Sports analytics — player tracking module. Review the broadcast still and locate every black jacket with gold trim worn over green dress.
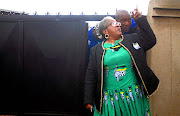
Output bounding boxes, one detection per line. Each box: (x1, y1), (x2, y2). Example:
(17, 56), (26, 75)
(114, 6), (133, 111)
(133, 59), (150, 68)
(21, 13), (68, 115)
(84, 17), (159, 112)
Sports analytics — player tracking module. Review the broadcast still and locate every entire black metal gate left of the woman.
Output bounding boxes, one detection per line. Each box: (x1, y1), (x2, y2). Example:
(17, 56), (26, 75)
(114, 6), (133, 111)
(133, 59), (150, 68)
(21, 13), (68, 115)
(0, 17), (87, 115)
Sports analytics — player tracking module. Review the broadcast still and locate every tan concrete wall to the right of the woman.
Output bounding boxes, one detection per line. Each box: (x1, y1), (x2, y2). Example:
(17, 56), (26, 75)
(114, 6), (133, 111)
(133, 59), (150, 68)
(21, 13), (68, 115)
(147, 0), (180, 116)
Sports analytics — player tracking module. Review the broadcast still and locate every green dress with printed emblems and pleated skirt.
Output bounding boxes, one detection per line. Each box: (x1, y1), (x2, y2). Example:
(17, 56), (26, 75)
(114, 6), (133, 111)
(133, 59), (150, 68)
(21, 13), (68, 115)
(94, 40), (151, 116)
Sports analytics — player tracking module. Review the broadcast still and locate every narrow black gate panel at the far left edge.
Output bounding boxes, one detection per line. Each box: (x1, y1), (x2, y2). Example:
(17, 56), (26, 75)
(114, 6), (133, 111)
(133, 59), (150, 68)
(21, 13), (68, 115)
(0, 22), (23, 111)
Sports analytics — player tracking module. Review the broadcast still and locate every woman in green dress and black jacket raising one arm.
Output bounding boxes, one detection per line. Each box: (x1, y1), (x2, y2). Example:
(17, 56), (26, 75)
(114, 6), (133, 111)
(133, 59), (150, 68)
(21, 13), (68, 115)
(84, 11), (159, 116)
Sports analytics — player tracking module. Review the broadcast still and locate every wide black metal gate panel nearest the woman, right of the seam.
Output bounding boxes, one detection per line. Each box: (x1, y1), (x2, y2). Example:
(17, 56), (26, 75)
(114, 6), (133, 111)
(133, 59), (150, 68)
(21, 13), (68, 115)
(24, 22), (87, 112)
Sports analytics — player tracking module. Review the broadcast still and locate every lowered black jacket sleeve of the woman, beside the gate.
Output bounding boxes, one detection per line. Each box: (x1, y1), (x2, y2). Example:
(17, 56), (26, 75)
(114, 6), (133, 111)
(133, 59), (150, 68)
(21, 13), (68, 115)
(84, 47), (96, 104)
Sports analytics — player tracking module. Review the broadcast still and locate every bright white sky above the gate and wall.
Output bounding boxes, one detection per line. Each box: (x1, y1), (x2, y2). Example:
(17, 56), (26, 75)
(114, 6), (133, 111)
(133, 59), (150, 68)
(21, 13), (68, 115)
(0, 0), (150, 15)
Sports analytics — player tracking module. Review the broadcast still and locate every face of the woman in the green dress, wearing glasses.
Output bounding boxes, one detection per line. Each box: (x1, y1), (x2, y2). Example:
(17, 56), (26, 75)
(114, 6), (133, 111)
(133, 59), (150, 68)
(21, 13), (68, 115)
(104, 19), (122, 39)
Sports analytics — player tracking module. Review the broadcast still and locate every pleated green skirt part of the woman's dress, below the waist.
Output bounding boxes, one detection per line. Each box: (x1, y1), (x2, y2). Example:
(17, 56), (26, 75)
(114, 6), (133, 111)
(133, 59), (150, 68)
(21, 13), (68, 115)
(94, 84), (151, 116)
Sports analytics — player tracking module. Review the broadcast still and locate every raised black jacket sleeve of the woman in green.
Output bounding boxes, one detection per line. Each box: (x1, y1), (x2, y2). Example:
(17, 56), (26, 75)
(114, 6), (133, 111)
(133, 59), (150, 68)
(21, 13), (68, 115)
(136, 16), (156, 51)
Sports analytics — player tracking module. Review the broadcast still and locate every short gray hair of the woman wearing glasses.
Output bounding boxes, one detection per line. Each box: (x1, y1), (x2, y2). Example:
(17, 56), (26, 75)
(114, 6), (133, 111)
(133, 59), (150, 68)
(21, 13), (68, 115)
(97, 16), (114, 37)
